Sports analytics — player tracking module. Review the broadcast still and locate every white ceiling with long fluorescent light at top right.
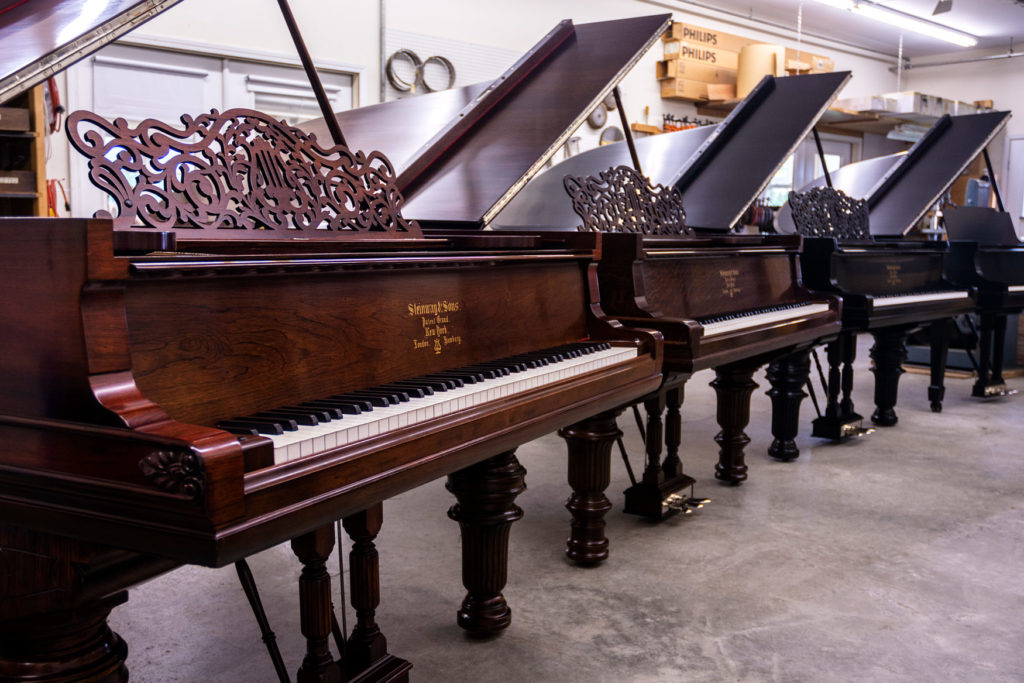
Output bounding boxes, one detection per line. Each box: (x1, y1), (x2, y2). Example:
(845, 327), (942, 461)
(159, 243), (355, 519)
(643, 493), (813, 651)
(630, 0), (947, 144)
(684, 0), (1024, 59)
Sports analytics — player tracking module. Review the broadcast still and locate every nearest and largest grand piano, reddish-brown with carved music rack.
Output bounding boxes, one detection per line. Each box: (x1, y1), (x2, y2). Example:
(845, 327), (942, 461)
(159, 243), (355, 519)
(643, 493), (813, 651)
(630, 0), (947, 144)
(0, 0), (665, 681)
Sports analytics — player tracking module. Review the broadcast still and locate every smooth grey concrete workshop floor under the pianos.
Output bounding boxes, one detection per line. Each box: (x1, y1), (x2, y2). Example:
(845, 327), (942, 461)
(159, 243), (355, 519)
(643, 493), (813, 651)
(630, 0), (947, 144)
(112, 348), (1024, 683)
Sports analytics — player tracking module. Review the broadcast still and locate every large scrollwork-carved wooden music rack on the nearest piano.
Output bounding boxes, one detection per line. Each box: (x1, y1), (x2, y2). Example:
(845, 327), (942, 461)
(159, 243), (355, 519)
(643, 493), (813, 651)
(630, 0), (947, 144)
(67, 109), (421, 239)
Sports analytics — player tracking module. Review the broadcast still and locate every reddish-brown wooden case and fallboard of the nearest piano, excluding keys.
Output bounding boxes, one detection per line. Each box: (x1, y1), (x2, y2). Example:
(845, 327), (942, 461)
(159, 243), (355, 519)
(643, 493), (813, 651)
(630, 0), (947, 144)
(0, 219), (662, 565)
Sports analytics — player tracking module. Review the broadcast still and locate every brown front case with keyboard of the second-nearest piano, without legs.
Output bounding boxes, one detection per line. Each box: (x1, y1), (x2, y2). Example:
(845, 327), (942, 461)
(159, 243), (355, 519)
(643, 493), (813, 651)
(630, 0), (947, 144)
(598, 233), (841, 372)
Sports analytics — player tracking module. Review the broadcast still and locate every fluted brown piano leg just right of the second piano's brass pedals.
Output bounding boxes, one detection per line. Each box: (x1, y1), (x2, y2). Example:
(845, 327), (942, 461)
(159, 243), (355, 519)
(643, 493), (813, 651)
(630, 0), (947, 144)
(711, 361), (760, 485)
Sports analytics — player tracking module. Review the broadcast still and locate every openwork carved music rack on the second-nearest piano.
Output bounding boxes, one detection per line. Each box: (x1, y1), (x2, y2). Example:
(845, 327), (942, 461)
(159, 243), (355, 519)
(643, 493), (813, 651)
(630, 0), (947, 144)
(563, 166), (693, 236)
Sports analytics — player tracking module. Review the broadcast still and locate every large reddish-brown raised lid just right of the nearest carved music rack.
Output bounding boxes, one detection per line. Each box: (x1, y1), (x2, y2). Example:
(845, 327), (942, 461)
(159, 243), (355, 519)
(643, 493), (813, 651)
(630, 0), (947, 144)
(303, 14), (671, 227)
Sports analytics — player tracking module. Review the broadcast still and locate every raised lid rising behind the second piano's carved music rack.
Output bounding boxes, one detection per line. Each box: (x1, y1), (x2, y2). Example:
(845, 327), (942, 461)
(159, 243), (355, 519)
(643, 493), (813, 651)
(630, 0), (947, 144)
(495, 72), (850, 230)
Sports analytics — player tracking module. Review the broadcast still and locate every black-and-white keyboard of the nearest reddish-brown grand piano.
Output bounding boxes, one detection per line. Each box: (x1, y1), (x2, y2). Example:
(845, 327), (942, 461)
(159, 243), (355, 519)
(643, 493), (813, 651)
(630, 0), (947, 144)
(217, 343), (637, 465)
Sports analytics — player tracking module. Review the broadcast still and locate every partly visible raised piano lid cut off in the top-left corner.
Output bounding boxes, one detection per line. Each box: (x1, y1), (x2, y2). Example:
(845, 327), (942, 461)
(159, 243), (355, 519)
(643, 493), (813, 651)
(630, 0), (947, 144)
(0, 0), (181, 102)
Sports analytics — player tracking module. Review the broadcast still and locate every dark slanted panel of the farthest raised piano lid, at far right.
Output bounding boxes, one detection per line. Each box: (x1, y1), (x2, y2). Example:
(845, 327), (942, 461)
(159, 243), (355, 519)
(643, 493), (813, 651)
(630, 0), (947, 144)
(866, 112), (1010, 236)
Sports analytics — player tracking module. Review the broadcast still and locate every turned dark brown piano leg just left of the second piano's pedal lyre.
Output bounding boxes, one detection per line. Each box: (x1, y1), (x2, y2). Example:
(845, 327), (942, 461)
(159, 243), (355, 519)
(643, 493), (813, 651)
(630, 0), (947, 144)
(558, 409), (623, 564)
